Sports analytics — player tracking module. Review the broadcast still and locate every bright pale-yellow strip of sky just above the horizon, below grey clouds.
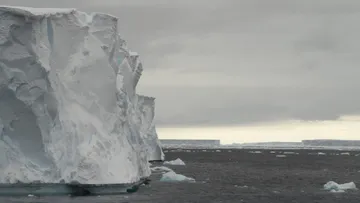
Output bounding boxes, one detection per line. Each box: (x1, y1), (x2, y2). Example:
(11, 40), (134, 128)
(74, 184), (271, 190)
(157, 116), (360, 144)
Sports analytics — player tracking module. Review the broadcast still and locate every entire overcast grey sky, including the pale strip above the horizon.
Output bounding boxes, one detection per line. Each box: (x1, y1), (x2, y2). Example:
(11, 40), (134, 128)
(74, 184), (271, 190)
(0, 0), (360, 143)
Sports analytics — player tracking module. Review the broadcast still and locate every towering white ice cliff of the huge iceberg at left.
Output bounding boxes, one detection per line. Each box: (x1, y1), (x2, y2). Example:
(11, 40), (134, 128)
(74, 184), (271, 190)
(0, 6), (163, 183)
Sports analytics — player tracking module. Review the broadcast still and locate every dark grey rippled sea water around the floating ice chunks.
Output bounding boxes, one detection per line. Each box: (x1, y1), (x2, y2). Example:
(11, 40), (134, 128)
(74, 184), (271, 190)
(0, 149), (360, 203)
